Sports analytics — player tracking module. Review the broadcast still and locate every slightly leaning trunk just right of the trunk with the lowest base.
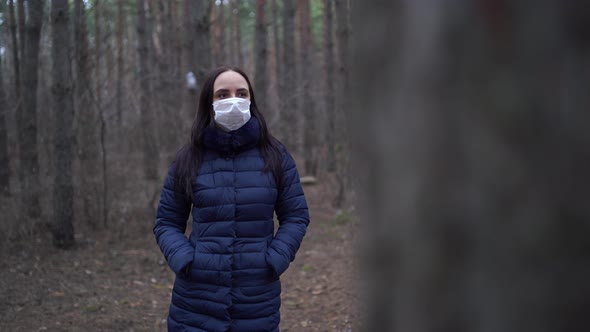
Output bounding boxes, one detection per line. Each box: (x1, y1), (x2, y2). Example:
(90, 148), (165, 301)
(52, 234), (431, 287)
(74, 0), (104, 228)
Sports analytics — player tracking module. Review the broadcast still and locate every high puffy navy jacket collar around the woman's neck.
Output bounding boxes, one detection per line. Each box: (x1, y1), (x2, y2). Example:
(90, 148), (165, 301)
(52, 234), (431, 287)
(203, 117), (260, 155)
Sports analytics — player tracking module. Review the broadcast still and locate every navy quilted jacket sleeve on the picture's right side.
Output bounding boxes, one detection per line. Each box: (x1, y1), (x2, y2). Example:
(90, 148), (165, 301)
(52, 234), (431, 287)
(266, 150), (309, 277)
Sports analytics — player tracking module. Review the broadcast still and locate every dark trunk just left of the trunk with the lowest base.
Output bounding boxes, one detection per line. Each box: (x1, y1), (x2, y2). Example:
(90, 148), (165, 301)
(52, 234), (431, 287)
(17, 0), (44, 219)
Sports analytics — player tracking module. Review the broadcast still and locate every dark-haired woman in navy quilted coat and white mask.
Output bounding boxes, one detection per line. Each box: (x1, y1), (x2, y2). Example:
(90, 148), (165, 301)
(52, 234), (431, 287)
(154, 67), (309, 332)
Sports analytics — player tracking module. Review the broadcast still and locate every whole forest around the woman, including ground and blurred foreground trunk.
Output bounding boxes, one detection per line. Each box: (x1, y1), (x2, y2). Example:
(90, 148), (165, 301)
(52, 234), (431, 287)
(0, 0), (590, 332)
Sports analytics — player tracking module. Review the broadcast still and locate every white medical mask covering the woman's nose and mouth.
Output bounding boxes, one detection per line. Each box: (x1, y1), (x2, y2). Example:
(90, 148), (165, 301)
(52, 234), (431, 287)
(213, 98), (250, 131)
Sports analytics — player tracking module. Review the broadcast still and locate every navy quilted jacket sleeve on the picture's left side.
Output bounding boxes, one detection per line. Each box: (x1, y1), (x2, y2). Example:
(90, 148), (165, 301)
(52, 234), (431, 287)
(153, 166), (195, 274)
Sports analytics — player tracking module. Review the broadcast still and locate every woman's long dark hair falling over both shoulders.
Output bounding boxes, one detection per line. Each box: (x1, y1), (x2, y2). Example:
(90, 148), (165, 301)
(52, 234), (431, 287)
(173, 66), (282, 197)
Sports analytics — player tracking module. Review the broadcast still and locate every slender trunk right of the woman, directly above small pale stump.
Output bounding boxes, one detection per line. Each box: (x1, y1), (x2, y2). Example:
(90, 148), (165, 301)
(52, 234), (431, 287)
(298, 0), (318, 176)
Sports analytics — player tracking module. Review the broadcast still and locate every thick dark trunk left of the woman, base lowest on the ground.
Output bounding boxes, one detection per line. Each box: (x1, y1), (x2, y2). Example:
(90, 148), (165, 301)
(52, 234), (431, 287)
(51, 0), (78, 249)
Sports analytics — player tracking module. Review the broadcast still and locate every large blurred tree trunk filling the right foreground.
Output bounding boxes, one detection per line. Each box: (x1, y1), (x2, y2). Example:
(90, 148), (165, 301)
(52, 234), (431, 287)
(349, 0), (590, 332)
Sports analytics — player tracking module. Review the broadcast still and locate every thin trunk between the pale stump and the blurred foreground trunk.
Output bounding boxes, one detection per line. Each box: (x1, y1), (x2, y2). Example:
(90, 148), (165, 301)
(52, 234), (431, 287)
(324, 0), (340, 172)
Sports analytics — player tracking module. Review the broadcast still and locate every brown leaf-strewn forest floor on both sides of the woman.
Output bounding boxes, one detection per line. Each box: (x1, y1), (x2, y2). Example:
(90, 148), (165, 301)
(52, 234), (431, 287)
(0, 169), (360, 332)
